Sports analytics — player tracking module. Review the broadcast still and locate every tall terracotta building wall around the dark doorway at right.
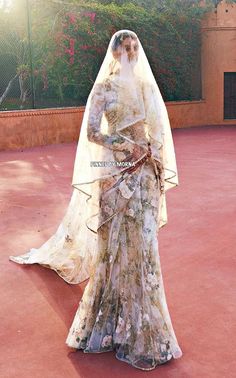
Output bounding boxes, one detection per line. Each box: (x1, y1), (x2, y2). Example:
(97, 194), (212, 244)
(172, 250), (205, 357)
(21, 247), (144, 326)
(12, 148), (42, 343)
(202, 2), (236, 125)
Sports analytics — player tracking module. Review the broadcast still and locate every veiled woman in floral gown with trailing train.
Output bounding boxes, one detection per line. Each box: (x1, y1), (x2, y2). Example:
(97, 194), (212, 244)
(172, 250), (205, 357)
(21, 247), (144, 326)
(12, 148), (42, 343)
(10, 30), (182, 370)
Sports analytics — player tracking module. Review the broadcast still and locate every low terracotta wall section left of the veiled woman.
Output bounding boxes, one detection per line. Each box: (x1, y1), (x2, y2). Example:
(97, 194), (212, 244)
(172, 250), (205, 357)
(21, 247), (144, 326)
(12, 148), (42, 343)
(0, 107), (84, 150)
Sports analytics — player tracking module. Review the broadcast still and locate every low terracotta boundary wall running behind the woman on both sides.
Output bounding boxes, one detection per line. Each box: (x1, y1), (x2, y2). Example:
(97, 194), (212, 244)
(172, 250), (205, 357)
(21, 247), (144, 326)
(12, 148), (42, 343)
(0, 101), (210, 150)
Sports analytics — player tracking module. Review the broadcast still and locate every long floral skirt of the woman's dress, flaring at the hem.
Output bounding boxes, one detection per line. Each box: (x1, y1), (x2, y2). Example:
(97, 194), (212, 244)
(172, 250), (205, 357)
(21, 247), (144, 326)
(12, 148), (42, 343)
(66, 163), (182, 370)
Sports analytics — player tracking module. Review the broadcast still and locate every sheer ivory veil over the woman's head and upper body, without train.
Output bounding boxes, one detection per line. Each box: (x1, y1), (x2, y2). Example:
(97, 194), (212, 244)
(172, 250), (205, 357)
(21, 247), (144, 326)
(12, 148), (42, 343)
(72, 30), (178, 232)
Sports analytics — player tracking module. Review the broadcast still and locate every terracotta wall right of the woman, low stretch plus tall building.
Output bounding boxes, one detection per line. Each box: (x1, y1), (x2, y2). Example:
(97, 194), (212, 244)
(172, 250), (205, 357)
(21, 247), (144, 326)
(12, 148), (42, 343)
(166, 1), (236, 128)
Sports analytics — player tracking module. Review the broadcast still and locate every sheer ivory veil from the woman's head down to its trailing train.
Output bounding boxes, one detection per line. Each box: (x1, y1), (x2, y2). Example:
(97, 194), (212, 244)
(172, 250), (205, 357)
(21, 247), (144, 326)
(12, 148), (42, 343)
(10, 30), (178, 284)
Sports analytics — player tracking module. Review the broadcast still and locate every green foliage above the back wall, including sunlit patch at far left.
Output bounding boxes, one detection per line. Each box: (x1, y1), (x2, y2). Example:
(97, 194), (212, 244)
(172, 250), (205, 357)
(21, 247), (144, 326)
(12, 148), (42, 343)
(0, 0), (233, 107)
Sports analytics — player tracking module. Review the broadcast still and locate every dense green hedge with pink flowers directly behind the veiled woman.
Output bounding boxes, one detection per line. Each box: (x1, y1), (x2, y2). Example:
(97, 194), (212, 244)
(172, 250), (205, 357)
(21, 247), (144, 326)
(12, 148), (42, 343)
(27, 0), (208, 105)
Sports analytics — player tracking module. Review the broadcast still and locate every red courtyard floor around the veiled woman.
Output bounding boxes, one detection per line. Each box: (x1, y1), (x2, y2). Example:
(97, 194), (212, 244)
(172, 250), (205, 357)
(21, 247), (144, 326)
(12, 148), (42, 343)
(0, 126), (236, 378)
